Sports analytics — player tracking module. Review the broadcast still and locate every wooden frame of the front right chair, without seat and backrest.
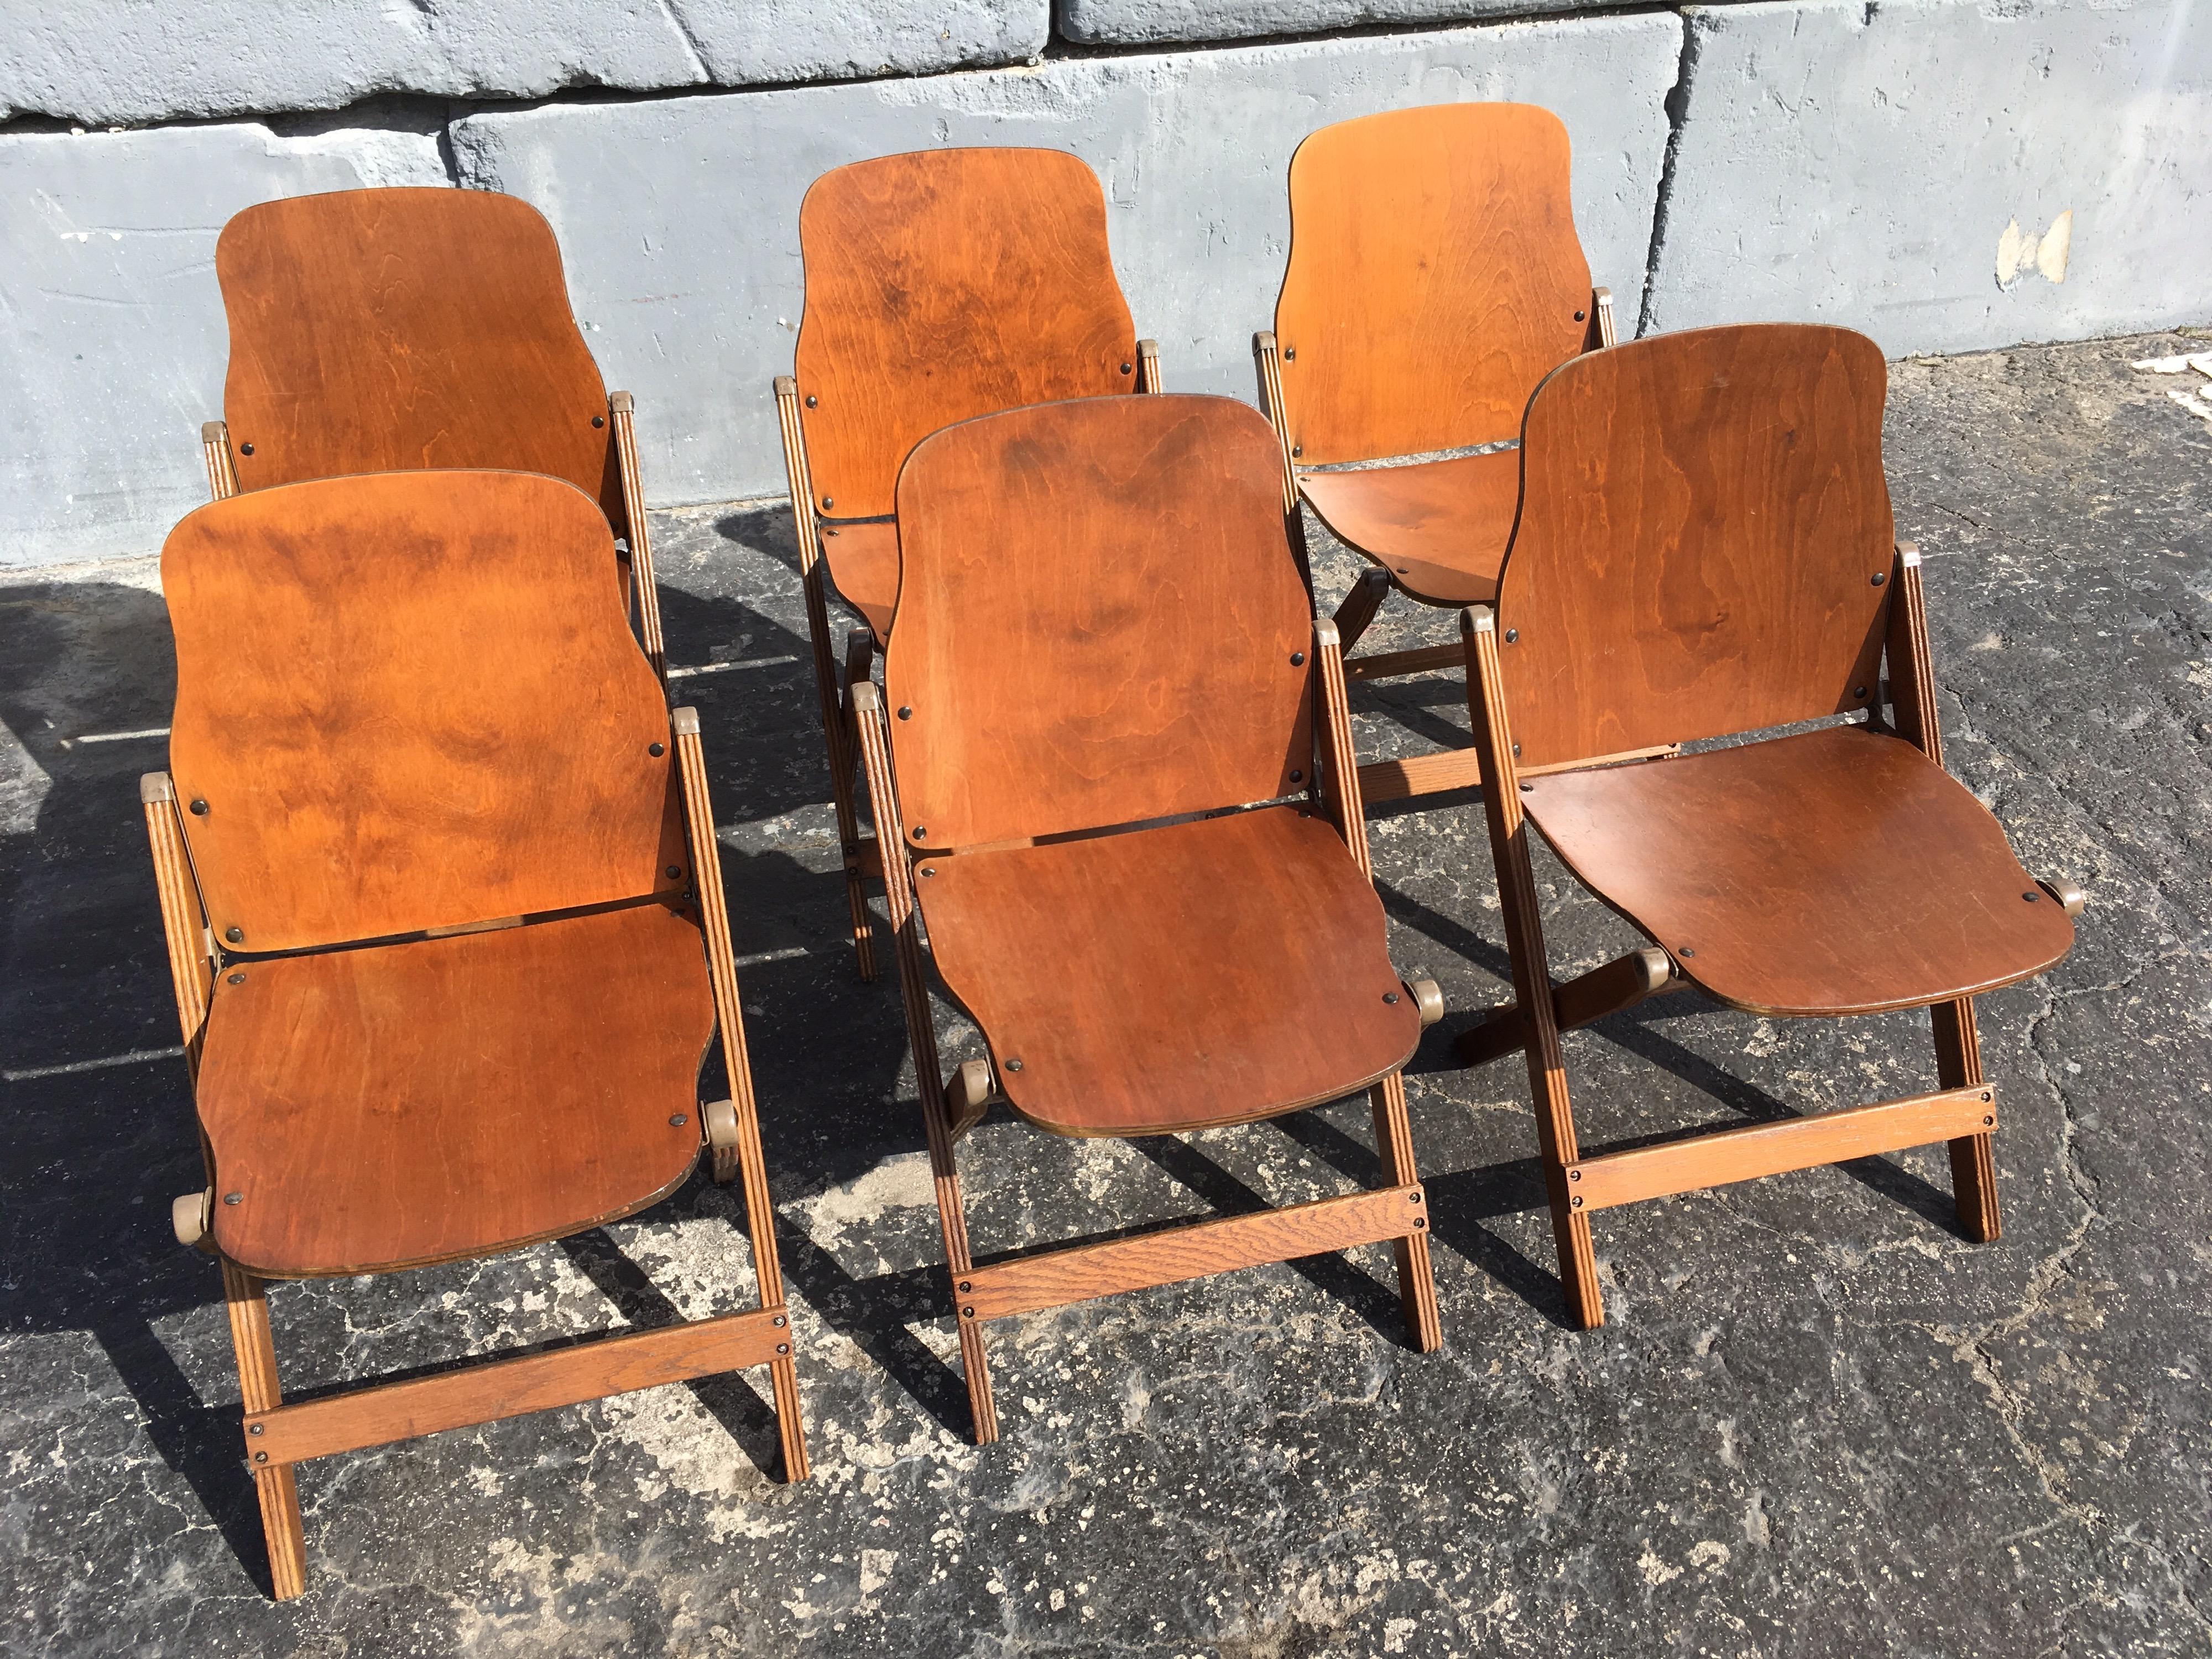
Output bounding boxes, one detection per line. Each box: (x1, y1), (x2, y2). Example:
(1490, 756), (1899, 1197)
(1458, 553), (2081, 1329)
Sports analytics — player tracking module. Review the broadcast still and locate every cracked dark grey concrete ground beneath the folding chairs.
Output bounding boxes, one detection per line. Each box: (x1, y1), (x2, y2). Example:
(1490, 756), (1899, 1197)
(0, 336), (2212, 1659)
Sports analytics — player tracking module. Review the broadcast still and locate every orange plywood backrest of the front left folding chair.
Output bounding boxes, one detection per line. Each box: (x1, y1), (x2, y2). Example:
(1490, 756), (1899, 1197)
(161, 471), (690, 951)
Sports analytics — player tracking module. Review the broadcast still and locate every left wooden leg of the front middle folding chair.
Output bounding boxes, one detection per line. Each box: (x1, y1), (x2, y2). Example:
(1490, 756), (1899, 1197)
(852, 681), (998, 1447)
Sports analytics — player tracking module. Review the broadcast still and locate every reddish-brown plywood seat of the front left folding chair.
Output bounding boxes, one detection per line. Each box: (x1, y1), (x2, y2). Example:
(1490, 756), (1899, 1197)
(199, 905), (714, 1279)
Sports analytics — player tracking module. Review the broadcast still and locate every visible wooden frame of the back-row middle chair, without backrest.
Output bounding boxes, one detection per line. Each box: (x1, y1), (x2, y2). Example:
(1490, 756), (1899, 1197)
(774, 338), (1161, 980)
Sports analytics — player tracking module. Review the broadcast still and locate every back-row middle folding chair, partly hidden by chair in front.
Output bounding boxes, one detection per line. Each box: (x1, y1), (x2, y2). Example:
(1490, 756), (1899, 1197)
(776, 148), (1159, 980)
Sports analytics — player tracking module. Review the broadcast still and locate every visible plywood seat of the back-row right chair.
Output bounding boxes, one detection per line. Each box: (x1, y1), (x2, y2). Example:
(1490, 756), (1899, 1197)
(1298, 449), (1520, 606)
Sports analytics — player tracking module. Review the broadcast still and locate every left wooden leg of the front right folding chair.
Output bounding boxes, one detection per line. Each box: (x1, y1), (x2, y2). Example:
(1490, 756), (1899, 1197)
(1460, 606), (1606, 1329)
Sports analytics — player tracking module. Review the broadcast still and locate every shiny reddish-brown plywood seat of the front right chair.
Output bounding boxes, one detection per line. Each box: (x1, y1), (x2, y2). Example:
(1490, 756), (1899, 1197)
(1522, 730), (2073, 1015)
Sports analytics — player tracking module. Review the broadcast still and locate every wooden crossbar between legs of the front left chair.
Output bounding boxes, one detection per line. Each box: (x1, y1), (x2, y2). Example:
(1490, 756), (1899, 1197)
(246, 1307), (790, 1469)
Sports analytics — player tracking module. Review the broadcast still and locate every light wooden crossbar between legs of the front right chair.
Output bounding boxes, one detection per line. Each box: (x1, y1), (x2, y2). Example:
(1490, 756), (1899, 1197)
(1566, 1084), (1997, 1210)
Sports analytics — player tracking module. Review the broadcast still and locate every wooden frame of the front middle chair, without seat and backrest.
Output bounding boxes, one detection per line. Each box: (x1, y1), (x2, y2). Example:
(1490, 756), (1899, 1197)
(852, 622), (1442, 1444)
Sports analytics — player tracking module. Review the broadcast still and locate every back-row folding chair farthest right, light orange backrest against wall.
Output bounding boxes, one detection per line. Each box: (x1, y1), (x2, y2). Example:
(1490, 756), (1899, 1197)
(1252, 104), (1613, 803)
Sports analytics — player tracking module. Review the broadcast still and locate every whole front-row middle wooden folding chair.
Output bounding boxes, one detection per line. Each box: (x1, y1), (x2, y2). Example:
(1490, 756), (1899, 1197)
(854, 396), (1442, 1442)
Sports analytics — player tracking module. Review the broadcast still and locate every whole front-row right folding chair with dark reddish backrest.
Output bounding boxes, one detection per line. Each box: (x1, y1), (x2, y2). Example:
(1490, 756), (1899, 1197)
(1458, 325), (2081, 1325)
